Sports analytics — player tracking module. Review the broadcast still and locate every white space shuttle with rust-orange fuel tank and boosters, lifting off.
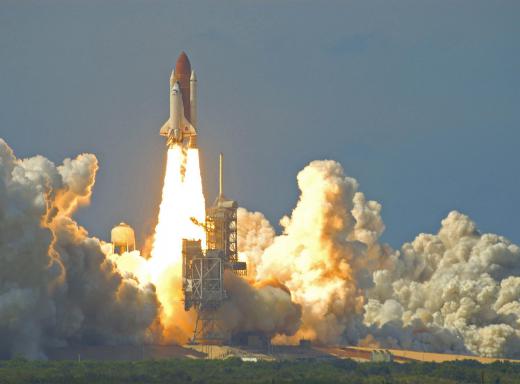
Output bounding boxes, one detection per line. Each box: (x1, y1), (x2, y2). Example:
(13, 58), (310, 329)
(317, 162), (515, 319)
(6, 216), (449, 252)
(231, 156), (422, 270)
(159, 52), (197, 148)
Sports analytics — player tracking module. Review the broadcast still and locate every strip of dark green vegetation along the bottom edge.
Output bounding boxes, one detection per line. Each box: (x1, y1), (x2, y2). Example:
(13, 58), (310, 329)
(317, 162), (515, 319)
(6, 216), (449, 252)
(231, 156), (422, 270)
(0, 358), (520, 384)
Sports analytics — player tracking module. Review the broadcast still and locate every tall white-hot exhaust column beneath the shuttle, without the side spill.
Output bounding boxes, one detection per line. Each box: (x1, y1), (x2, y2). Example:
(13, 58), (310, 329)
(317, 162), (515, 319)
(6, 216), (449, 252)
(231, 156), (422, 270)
(148, 146), (206, 333)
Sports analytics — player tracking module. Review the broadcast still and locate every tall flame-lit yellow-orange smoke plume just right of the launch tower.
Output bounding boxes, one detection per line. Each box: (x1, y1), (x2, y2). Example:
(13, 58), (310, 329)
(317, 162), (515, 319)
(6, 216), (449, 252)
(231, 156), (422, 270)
(239, 161), (366, 343)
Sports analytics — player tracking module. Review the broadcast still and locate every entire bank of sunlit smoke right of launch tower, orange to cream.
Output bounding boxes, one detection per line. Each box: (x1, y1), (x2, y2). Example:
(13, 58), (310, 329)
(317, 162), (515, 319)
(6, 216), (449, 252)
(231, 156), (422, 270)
(238, 161), (520, 356)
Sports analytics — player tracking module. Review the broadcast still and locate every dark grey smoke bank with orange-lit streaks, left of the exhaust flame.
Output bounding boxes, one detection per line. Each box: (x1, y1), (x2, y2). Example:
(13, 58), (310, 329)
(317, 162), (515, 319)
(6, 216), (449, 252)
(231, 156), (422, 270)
(0, 139), (158, 357)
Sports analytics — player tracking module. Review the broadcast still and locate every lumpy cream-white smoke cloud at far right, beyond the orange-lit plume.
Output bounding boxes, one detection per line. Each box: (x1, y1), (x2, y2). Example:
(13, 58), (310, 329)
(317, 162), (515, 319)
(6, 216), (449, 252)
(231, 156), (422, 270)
(365, 211), (520, 356)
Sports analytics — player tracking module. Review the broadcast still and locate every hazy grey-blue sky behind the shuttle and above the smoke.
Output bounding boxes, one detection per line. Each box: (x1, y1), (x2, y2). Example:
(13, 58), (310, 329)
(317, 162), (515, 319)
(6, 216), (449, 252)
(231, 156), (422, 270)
(0, 0), (520, 246)
